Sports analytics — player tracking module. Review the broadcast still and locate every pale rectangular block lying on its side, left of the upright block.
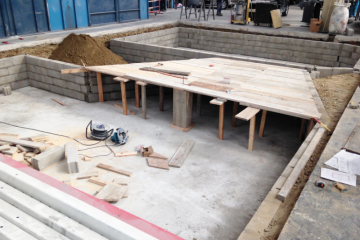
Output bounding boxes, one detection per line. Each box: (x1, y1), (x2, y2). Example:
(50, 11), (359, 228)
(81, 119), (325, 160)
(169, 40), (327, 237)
(31, 146), (65, 171)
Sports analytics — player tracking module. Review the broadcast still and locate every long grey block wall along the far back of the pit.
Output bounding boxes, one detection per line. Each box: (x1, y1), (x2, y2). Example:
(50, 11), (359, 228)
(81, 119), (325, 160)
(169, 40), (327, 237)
(178, 28), (360, 67)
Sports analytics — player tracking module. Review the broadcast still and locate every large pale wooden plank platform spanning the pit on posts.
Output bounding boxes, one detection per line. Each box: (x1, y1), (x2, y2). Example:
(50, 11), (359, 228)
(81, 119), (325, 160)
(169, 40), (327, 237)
(87, 58), (321, 119)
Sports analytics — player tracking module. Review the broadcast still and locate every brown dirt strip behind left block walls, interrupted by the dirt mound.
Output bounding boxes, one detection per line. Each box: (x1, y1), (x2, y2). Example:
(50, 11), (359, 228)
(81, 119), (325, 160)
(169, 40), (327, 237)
(0, 24), (174, 59)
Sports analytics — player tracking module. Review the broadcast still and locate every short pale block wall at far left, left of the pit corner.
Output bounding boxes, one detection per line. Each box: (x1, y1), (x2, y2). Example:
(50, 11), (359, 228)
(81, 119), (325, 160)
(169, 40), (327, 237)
(0, 55), (29, 91)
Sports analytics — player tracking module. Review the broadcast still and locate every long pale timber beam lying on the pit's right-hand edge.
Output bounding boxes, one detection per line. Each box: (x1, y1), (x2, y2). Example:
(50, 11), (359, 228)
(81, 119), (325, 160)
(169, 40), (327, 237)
(276, 128), (325, 201)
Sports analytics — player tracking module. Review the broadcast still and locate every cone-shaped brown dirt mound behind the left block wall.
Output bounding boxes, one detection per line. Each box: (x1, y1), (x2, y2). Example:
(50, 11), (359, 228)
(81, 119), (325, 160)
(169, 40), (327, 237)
(49, 33), (127, 66)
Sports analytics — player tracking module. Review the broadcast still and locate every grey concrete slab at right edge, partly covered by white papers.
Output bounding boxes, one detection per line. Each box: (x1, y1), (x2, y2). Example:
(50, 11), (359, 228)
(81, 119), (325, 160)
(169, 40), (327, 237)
(279, 88), (360, 240)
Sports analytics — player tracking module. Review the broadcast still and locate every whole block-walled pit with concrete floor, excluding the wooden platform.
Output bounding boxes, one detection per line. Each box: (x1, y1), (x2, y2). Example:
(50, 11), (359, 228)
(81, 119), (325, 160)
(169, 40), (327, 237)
(0, 22), (360, 239)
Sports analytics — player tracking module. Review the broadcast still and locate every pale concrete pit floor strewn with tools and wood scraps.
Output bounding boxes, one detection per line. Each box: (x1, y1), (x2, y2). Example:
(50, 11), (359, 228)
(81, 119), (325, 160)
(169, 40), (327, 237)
(0, 87), (301, 240)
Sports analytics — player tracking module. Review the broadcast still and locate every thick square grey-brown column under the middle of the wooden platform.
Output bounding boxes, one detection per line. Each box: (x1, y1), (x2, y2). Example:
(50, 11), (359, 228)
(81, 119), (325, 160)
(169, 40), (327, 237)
(171, 88), (194, 132)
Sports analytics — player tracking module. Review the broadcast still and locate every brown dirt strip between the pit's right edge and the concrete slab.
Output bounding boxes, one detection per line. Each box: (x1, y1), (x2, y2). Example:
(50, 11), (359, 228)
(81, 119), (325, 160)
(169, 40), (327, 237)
(261, 73), (360, 240)
